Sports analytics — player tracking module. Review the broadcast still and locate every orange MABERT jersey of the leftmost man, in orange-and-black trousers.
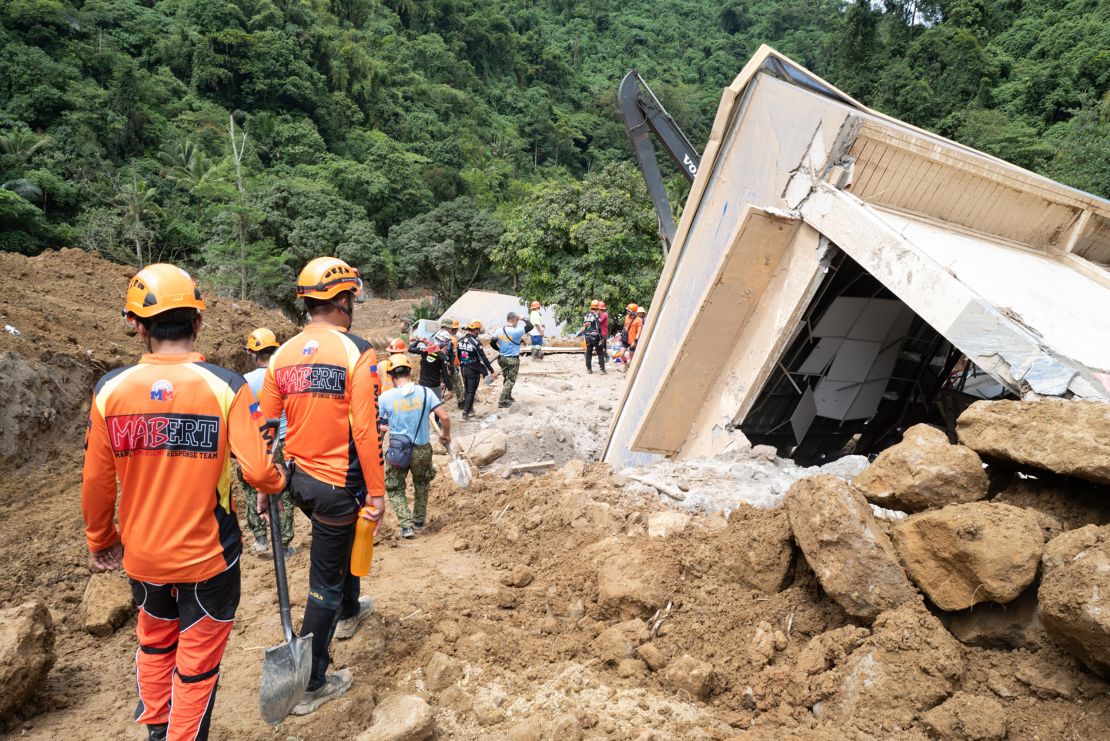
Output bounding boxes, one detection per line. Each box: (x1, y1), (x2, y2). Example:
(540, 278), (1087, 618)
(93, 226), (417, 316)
(81, 353), (285, 583)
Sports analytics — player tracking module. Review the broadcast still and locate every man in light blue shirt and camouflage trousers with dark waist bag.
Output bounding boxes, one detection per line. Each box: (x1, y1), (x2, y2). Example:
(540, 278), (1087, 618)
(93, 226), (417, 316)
(379, 355), (451, 538)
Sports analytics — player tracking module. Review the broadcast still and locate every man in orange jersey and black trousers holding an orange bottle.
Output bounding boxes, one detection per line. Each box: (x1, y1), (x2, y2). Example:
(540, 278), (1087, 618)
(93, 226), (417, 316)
(258, 257), (385, 715)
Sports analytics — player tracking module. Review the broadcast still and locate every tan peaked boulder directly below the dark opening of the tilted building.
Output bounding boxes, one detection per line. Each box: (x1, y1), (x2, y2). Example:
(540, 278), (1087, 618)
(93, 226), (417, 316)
(852, 425), (990, 512)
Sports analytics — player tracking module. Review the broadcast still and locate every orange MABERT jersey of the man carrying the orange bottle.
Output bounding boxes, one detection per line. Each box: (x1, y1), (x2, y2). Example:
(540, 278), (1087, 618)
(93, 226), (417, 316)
(260, 324), (385, 497)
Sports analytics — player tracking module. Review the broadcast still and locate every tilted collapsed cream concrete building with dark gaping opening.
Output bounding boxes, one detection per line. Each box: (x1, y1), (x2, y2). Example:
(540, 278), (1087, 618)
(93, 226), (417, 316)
(604, 47), (1110, 467)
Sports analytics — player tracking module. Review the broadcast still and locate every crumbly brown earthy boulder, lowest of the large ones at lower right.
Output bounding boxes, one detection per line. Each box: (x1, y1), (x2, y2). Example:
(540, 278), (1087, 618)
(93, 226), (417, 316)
(830, 603), (963, 737)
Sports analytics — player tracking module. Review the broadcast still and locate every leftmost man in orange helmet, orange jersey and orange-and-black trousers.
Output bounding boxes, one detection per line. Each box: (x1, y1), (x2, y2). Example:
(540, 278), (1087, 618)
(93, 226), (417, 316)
(81, 264), (285, 741)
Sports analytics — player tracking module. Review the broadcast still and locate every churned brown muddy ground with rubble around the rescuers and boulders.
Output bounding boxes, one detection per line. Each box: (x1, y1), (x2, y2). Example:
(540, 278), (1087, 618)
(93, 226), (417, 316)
(0, 253), (1110, 741)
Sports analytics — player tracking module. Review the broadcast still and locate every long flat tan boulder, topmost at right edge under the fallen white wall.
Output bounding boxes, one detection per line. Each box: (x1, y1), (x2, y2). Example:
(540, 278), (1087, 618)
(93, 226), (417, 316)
(957, 398), (1110, 484)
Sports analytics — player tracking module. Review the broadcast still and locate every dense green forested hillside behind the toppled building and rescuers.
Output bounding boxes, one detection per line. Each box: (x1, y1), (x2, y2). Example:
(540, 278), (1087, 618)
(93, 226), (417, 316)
(0, 0), (1110, 315)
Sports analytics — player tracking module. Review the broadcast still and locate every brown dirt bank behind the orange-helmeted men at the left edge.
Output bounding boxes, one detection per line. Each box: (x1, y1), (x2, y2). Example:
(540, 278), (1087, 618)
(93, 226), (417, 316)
(0, 250), (293, 467)
